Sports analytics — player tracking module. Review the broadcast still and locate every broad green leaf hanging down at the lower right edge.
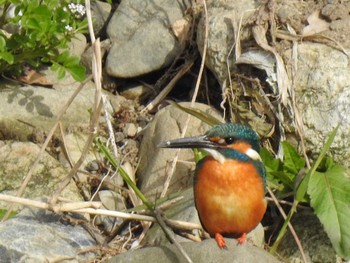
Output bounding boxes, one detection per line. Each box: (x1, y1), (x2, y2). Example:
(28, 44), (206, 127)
(307, 162), (350, 260)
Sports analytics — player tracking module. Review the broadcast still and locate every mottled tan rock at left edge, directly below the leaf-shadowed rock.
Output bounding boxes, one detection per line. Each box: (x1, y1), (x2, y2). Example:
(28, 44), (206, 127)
(0, 141), (82, 208)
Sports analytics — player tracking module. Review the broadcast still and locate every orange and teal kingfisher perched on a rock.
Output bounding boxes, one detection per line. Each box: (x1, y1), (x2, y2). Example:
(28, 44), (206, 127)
(159, 123), (266, 249)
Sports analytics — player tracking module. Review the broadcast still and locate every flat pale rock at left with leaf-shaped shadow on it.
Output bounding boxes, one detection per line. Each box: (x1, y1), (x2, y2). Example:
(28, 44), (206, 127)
(0, 79), (113, 141)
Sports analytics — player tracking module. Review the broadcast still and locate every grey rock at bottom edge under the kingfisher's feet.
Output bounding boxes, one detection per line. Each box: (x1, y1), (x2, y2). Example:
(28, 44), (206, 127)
(109, 239), (280, 263)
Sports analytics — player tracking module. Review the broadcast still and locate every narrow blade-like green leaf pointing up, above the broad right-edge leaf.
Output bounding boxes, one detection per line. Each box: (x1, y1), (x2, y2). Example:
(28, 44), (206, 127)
(295, 124), (339, 201)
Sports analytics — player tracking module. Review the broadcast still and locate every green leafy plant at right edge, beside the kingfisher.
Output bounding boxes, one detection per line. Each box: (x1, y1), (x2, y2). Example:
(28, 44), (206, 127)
(264, 126), (350, 259)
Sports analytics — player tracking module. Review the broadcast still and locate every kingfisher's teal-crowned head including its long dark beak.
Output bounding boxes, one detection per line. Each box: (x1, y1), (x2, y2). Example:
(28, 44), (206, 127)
(159, 123), (261, 163)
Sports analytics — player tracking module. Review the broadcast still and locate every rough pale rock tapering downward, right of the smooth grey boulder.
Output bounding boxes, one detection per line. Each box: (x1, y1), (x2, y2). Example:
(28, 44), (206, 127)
(197, 0), (258, 85)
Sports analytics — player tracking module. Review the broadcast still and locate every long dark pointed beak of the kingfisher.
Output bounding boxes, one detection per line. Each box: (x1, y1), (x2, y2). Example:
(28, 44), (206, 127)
(158, 135), (216, 148)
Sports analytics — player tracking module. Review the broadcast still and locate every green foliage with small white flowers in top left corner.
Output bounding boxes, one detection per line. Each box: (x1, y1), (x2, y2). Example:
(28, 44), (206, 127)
(0, 0), (87, 81)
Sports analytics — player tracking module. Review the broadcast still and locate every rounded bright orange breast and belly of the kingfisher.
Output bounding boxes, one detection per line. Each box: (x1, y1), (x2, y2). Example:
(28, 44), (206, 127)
(194, 157), (266, 237)
